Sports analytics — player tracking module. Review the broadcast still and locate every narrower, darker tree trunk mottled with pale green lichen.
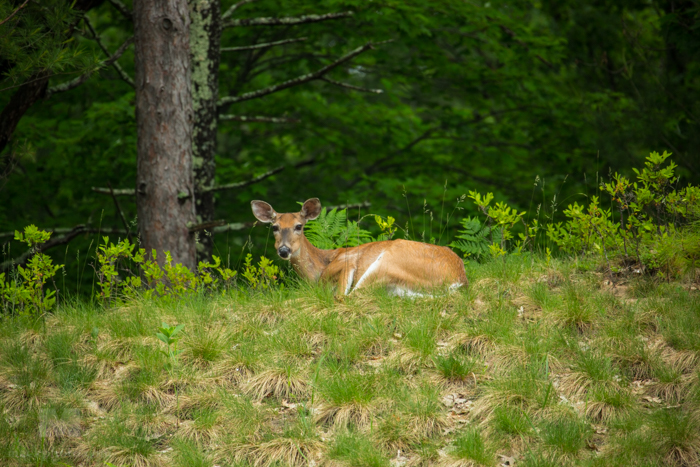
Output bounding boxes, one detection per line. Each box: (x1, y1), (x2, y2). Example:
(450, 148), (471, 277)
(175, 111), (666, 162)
(190, 0), (221, 260)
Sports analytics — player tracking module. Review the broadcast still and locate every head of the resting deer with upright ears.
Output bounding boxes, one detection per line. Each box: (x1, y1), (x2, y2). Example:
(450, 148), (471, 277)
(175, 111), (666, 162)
(250, 198), (321, 259)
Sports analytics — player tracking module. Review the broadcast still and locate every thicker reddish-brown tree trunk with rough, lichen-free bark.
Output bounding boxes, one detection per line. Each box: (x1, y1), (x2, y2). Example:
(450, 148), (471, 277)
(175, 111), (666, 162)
(134, 0), (196, 269)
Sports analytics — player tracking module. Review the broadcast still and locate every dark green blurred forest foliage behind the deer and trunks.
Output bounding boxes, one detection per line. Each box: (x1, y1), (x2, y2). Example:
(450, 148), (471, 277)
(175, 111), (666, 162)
(0, 0), (700, 288)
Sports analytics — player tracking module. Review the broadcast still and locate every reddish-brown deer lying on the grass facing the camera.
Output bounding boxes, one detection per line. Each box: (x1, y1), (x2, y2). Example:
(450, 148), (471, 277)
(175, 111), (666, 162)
(251, 198), (467, 297)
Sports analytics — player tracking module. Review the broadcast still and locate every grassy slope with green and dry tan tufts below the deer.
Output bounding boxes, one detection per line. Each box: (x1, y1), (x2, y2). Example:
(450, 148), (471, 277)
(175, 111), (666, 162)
(0, 257), (700, 467)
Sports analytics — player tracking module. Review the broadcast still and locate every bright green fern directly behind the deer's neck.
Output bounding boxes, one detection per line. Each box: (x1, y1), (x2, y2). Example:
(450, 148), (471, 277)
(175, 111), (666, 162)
(304, 208), (374, 250)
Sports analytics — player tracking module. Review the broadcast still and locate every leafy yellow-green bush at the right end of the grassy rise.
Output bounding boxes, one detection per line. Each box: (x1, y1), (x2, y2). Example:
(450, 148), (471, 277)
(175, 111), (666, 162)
(547, 152), (700, 276)
